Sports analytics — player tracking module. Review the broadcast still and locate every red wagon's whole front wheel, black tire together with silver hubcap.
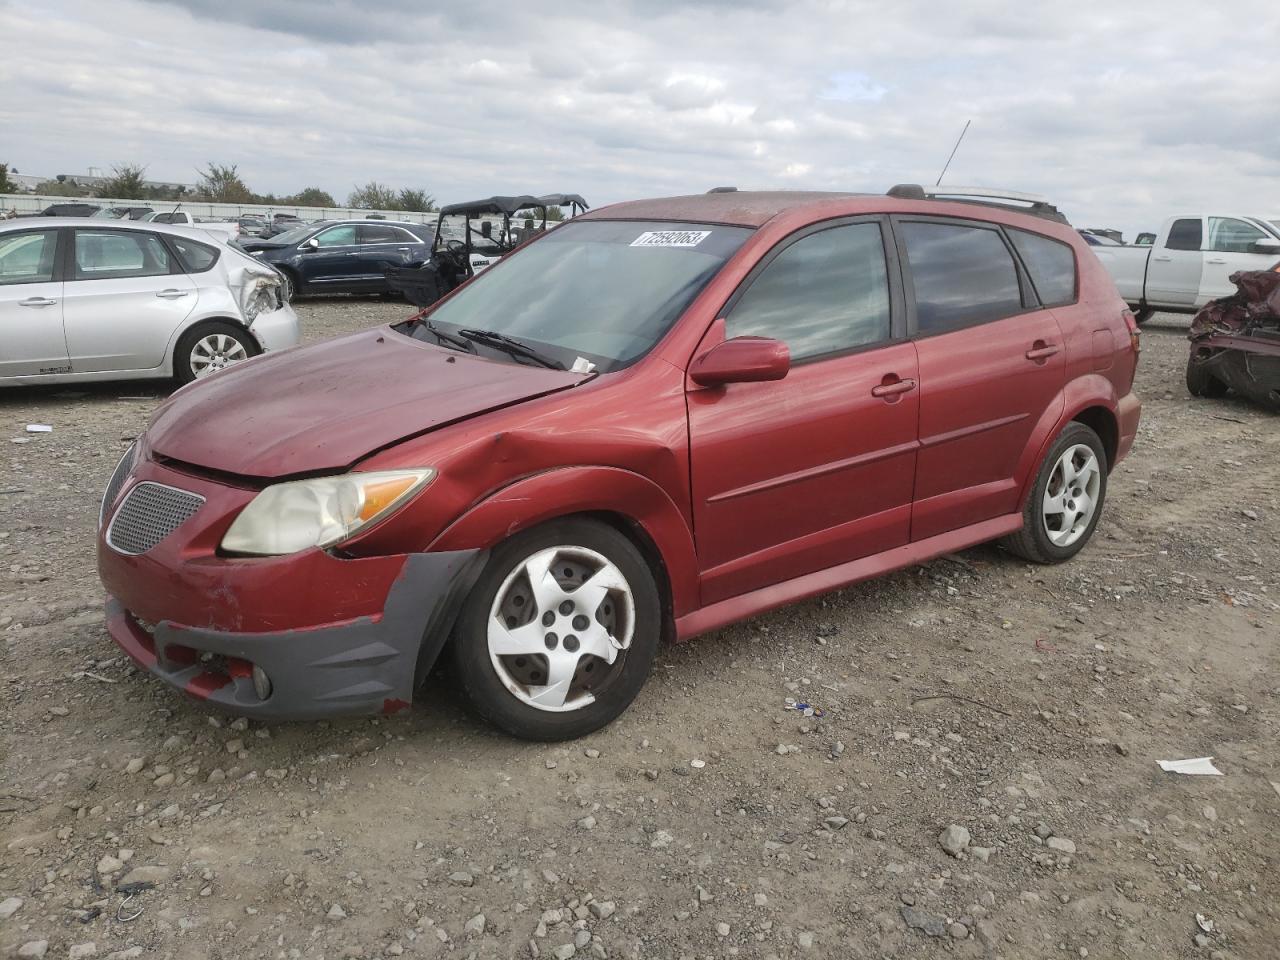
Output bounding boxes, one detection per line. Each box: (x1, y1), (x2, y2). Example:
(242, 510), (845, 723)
(449, 520), (663, 741)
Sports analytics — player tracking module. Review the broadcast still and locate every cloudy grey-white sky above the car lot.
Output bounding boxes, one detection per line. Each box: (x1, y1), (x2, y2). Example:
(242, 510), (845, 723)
(0, 0), (1280, 234)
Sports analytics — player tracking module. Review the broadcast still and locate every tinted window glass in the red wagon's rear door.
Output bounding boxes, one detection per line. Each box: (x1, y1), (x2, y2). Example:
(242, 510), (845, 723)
(900, 223), (1023, 334)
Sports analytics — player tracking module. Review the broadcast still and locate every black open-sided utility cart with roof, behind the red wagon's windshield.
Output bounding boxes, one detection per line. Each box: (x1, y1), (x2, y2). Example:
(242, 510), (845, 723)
(387, 193), (588, 307)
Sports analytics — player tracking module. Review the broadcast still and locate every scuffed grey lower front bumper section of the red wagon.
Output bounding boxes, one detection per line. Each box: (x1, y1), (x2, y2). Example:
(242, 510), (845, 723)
(106, 550), (483, 721)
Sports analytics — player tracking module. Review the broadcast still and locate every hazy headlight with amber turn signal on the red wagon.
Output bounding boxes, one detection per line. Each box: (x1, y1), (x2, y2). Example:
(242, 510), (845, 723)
(223, 467), (435, 557)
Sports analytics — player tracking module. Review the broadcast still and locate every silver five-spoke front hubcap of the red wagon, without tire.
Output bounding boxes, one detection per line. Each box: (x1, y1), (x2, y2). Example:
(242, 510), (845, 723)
(486, 545), (635, 713)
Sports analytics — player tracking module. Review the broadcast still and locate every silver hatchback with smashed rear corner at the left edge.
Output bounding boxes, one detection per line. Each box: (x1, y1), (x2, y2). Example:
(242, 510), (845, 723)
(0, 218), (298, 385)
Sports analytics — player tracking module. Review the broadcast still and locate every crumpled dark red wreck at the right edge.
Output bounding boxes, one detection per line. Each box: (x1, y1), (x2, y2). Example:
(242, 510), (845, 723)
(1187, 264), (1280, 412)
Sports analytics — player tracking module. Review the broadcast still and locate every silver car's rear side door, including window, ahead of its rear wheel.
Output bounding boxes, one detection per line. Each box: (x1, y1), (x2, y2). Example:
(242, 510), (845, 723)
(64, 227), (198, 374)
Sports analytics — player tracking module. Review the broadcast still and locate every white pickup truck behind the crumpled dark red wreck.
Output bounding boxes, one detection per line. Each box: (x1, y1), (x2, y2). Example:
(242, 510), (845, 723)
(1091, 215), (1280, 324)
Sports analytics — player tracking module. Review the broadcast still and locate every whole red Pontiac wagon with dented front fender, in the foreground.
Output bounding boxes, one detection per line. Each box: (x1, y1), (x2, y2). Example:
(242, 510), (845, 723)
(99, 187), (1139, 740)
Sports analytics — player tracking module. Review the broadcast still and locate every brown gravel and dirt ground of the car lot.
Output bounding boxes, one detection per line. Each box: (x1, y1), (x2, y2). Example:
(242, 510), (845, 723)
(0, 300), (1280, 960)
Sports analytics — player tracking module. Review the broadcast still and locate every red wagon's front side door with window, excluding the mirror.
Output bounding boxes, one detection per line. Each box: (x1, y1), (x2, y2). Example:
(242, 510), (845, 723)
(687, 219), (919, 604)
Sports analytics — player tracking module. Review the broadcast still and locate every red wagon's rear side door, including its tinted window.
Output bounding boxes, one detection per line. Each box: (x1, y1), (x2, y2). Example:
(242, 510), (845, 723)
(893, 216), (1074, 540)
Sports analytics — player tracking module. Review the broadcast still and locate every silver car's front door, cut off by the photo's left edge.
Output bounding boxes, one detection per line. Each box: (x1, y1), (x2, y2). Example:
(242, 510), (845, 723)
(0, 229), (70, 378)
